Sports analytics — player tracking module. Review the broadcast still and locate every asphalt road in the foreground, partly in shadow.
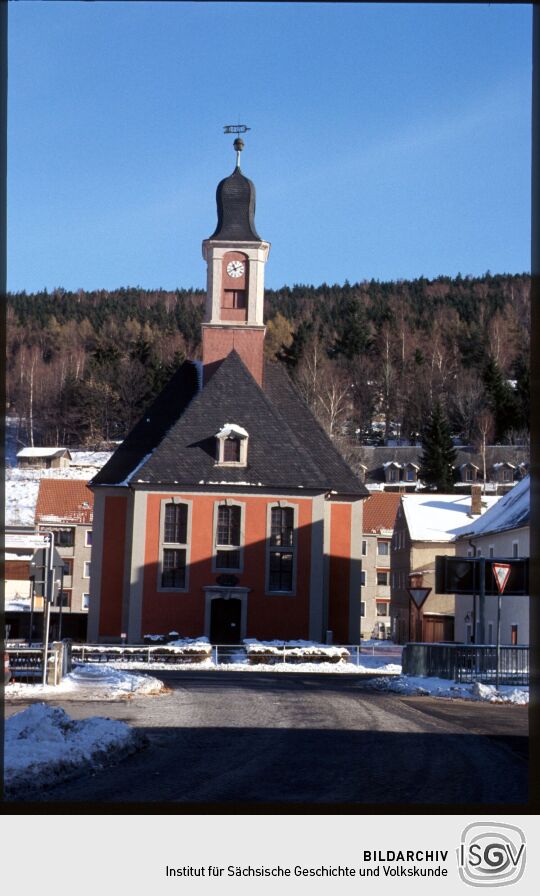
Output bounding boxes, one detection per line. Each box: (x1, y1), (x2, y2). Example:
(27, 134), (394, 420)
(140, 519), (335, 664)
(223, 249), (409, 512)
(7, 672), (527, 812)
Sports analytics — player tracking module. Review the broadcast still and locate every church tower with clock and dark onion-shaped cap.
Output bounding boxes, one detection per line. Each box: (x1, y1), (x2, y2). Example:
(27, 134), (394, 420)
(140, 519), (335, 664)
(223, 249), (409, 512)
(202, 137), (270, 386)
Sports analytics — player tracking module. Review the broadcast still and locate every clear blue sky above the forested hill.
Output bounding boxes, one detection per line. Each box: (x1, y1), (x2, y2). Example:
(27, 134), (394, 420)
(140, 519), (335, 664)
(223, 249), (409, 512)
(8, 0), (532, 291)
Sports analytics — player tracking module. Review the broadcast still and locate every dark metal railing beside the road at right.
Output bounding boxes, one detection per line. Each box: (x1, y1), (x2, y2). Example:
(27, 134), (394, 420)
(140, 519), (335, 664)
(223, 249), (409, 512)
(402, 644), (529, 685)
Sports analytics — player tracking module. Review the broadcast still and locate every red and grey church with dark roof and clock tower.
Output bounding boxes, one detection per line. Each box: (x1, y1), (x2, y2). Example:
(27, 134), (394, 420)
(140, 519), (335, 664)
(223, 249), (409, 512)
(88, 138), (368, 644)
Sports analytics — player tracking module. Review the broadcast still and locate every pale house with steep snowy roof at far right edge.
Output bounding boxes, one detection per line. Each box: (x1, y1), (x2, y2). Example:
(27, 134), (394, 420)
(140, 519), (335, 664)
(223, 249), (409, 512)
(455, 476), (531, 644)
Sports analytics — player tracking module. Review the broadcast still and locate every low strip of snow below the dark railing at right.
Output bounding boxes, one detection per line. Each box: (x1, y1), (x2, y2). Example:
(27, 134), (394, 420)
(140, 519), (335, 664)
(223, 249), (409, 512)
(367, 675), (529, 706)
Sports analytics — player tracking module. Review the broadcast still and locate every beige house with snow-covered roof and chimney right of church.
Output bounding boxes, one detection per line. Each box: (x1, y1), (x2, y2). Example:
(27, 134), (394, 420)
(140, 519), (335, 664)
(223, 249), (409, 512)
(390, 486), (498, 643)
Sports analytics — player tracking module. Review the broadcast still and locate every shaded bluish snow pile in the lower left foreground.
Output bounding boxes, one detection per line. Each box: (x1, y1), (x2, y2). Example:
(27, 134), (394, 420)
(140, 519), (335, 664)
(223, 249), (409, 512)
(4, 703), (145, 799)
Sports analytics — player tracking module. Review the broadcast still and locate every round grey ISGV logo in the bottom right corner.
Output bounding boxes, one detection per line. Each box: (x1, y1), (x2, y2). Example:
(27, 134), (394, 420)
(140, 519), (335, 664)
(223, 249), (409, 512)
(457, 822), (526, 887)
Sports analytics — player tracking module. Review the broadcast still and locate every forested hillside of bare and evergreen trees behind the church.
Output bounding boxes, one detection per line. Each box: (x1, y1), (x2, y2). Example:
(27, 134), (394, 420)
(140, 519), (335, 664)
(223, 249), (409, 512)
(7, 274), (530, 456)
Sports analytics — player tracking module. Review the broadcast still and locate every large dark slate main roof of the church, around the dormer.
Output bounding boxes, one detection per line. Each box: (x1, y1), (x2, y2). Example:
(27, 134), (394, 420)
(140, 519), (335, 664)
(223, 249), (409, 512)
(92, 351), (368, 497)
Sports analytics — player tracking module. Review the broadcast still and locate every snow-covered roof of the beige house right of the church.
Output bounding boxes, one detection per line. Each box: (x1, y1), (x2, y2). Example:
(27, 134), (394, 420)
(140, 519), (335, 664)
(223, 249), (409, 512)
(401, 493), (500, 542)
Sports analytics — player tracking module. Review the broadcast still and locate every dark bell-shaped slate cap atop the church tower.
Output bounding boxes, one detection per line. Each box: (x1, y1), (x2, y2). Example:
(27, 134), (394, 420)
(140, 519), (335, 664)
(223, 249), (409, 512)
(210, 168), (261, 242)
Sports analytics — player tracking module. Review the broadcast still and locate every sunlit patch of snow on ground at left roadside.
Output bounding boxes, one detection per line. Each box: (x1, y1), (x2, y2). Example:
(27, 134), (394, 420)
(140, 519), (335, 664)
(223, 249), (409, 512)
(5, 663), (166, 700)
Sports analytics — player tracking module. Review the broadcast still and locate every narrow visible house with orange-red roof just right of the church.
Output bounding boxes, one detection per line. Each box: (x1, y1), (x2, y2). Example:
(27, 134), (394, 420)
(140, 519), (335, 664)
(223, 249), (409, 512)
(360, 492), (400, 638)
